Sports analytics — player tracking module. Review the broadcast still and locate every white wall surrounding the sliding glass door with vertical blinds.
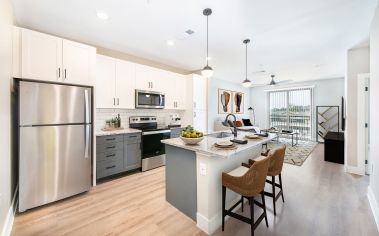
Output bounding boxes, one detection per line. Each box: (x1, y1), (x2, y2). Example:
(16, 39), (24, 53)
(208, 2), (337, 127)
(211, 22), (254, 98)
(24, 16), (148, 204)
(251, 78), (344, 138)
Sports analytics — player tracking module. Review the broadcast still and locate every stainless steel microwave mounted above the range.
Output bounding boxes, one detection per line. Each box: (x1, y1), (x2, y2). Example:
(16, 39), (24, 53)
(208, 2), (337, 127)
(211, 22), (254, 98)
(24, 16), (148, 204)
(136, 89), (165, 109)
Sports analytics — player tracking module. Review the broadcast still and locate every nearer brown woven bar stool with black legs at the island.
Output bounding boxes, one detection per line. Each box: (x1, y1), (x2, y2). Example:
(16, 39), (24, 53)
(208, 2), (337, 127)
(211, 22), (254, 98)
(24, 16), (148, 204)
(222, 157), (270, 235)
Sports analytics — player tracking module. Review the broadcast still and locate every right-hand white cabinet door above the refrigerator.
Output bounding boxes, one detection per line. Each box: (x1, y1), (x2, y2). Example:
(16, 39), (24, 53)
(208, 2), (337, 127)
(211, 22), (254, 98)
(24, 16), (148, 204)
(63, 40), (96, 85)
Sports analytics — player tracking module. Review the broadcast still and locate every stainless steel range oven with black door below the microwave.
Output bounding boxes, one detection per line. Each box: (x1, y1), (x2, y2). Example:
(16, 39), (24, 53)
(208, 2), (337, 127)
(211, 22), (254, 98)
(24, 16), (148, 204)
(129, 116), (171, 171)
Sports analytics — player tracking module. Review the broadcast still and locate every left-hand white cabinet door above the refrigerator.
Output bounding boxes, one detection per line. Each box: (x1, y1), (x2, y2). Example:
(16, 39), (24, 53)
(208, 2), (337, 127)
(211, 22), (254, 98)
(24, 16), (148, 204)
(21, 29), (63, 81)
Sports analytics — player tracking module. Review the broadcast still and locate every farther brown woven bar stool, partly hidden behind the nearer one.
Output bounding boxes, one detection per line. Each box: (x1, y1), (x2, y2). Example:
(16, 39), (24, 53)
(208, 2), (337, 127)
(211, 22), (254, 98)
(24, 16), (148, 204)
(248, 145), (286, 215)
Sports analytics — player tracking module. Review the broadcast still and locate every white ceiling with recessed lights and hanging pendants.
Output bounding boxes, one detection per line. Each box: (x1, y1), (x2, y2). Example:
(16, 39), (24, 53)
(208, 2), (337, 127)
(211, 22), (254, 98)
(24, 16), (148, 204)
(13, 0), (377, 83)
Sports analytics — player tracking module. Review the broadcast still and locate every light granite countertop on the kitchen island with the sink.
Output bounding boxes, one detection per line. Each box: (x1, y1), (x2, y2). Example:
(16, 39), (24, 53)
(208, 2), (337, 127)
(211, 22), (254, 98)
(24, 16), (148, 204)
(161, 131), (276, 158)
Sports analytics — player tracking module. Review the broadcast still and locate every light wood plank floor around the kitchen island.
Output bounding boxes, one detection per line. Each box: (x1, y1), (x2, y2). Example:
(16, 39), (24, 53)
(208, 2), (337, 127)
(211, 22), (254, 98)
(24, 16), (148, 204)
(12, 145), (379, 236)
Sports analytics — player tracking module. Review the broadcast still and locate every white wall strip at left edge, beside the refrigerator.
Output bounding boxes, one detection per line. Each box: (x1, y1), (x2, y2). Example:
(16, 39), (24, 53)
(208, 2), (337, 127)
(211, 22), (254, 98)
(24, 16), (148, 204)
(0, 0), (13, 234)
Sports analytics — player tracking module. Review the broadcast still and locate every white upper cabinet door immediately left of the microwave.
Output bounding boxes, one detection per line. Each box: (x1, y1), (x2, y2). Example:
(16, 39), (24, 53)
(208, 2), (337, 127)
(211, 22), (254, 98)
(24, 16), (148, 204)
(116, 60), (136, 109)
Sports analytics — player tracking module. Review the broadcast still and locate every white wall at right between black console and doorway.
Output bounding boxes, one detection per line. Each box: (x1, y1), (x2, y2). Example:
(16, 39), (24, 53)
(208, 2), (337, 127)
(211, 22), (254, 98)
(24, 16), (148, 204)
(345, 47), (370, 168)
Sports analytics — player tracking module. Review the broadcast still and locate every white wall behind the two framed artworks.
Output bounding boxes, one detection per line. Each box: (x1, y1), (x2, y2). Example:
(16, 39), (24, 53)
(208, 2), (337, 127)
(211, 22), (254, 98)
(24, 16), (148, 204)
(208, 78), (251, 133)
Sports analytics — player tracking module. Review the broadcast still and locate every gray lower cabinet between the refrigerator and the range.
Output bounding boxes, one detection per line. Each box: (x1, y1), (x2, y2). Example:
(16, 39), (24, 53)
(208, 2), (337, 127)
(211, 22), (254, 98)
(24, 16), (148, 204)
(96, 133), (141, 179)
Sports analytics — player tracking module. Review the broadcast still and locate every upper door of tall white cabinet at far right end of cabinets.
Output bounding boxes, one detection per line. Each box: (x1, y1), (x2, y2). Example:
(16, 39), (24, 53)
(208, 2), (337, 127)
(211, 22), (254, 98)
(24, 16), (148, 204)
(193, 75), (208, 110)
